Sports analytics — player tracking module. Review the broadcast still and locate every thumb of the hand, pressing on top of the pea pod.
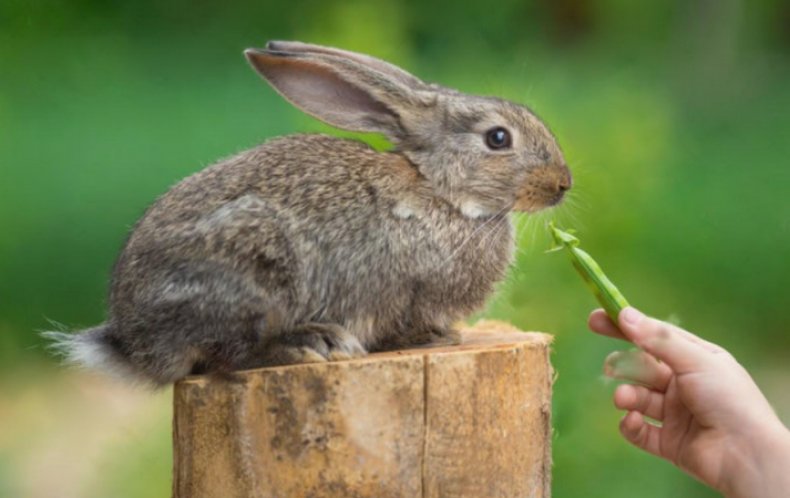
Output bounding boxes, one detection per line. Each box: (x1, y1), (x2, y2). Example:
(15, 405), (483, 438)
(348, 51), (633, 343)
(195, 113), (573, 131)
(618, 306), (709, 374)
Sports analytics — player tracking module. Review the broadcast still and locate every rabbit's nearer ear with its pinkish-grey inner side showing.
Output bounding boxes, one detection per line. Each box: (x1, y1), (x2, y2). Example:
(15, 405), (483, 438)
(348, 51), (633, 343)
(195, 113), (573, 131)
(244, 49), (426, 141)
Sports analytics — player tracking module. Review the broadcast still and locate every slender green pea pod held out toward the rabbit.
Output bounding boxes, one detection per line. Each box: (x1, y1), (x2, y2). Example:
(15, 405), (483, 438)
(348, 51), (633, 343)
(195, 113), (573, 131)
(549, 223), (628, 323)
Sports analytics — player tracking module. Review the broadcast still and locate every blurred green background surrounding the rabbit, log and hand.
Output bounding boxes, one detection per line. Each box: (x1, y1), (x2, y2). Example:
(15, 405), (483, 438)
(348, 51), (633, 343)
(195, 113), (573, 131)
(0, 0), (790, 497)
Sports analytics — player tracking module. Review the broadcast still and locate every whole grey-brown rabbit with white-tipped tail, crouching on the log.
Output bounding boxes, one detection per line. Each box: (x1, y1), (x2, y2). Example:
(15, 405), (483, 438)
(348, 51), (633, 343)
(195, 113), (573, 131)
(46, 41), (572, 386)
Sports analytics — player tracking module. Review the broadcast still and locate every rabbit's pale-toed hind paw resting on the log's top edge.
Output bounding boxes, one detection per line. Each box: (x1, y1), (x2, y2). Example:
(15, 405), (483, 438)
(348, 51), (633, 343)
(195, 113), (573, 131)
(264, 322), (367, 365)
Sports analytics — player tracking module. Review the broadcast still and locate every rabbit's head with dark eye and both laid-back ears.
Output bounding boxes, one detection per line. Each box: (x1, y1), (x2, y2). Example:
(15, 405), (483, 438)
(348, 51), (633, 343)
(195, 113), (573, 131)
(245, 41), (571, 218)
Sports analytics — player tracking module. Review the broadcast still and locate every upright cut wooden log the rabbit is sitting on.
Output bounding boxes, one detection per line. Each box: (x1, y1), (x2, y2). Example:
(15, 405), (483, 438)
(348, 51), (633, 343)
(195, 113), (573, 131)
(173, 322), (553, 498)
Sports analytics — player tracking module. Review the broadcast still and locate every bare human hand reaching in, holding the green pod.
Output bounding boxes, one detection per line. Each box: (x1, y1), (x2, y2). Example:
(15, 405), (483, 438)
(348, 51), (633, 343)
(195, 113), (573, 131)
(589, 308), (790, 497)
